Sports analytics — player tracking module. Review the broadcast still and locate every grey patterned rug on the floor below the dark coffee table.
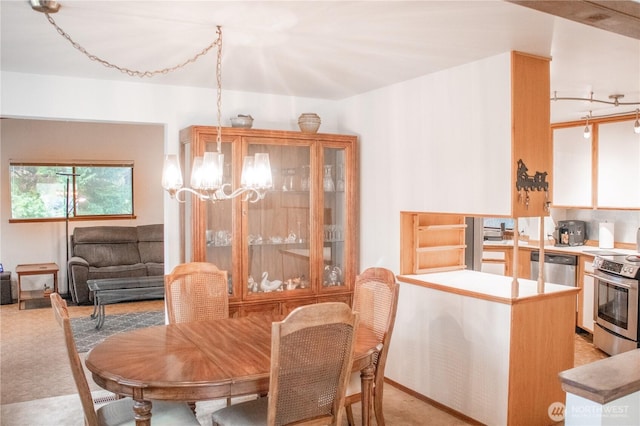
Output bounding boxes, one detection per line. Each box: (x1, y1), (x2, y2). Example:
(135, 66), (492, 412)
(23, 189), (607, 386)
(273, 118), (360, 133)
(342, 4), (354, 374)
(71, 311), (165, 353)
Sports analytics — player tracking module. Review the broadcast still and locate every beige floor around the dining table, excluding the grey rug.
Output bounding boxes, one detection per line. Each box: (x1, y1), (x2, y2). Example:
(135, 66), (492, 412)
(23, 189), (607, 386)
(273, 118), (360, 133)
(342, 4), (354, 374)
(0, 300), (606, 426)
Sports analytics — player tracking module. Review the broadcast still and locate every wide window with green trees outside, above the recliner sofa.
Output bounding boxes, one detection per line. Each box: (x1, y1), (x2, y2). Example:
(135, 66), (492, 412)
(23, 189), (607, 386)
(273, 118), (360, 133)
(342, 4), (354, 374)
(9, 163), (133, 220)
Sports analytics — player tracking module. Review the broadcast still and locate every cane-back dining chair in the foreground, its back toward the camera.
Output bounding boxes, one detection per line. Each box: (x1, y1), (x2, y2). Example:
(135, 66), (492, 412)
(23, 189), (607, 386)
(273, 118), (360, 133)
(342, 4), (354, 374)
(212, 302), (359, 426)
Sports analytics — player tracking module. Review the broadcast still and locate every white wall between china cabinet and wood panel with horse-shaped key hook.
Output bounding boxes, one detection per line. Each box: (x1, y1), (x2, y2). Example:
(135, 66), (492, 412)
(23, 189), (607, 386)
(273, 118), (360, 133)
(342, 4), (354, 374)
(339, 53), (511, 272)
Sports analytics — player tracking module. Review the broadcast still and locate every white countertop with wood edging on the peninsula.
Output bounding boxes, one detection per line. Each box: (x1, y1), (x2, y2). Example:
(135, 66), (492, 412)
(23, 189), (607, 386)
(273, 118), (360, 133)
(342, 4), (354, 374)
(398, 269), (579, 304)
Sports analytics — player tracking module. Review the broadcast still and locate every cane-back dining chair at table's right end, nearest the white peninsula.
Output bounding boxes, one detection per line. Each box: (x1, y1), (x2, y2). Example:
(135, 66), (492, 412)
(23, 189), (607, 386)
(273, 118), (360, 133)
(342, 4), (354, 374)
(345, 268), (400, 426)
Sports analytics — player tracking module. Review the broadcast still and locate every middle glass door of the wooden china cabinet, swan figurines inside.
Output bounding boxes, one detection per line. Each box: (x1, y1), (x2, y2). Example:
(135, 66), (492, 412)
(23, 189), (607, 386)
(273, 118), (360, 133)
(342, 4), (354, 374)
(243, 138), (312, 297)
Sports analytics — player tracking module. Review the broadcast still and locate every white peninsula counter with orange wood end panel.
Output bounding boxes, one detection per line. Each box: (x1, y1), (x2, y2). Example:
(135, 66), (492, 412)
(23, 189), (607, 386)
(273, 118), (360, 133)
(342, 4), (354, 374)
(385, 270), (579, 425)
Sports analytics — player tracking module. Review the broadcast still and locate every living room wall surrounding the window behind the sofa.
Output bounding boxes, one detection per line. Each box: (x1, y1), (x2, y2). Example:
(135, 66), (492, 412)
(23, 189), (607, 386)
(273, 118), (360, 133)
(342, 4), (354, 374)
(0, 119), (164, 296)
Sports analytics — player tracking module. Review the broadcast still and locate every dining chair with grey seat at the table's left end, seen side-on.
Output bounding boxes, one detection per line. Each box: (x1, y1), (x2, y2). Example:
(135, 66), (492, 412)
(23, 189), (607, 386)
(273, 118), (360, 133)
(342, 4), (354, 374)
(49, 293), (200, 426)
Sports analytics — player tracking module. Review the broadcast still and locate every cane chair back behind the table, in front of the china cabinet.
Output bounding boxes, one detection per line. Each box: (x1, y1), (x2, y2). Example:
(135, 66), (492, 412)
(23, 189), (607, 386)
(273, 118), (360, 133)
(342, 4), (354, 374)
(164, 262), (229, 324)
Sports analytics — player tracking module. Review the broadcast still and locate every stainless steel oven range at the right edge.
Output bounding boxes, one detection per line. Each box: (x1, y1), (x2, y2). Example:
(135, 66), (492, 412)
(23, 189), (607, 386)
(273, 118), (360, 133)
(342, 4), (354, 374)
(593, 254), (640, 355)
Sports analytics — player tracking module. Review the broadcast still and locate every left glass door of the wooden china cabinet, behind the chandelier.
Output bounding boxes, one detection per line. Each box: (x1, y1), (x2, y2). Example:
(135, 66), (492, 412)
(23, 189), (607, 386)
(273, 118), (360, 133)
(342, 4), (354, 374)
(201, 135), (239, 297)
